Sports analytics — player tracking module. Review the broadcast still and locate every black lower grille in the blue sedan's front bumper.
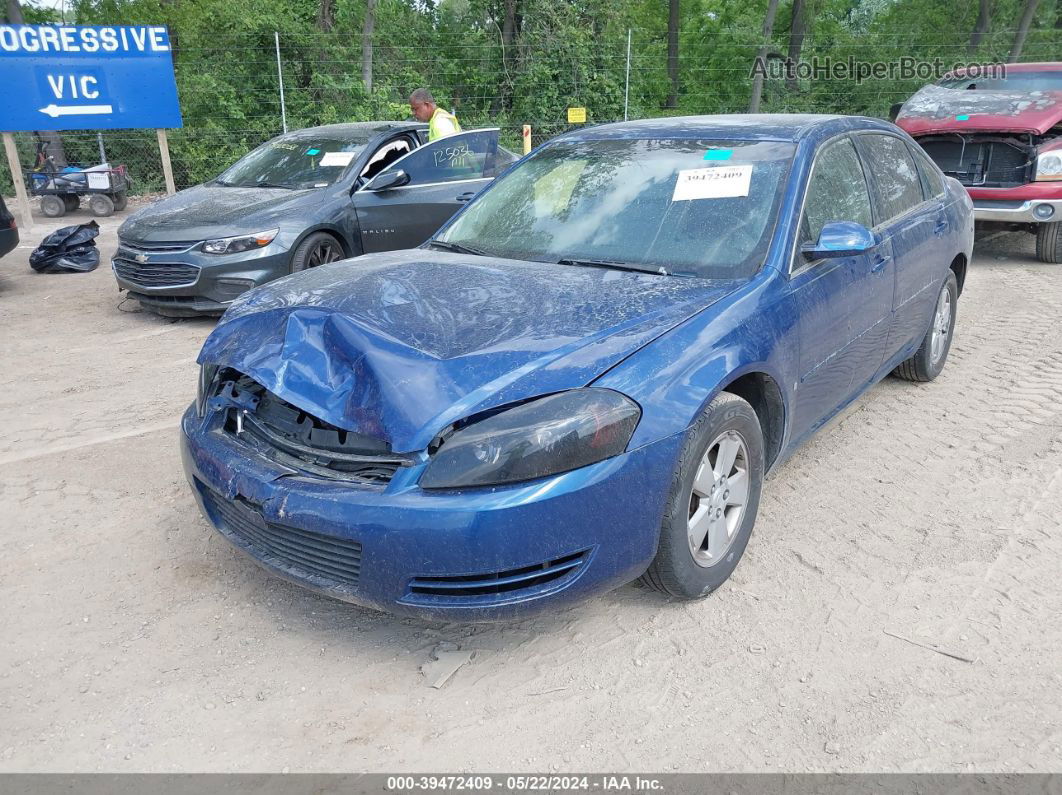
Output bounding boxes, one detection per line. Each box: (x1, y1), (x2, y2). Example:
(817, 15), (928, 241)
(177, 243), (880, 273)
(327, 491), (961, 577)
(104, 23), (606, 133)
(196, 481), (361, 587)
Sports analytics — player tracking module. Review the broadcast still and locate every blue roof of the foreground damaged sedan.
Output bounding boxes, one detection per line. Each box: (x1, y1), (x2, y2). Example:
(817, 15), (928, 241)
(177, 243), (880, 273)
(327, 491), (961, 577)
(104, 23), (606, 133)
(555, 114), (895, 141)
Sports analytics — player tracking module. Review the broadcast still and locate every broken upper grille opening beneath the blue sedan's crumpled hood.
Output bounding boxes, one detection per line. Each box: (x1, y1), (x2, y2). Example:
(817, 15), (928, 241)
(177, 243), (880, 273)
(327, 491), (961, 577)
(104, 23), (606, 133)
(213, 369), (413, 484)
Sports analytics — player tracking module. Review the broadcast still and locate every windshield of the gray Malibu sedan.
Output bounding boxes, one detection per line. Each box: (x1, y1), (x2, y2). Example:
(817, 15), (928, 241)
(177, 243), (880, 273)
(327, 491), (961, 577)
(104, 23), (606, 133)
(217, 135), (367, 189)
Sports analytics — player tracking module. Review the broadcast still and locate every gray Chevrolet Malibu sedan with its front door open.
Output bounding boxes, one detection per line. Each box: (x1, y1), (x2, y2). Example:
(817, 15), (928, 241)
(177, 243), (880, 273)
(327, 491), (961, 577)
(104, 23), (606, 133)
(112, 121), (516, 316)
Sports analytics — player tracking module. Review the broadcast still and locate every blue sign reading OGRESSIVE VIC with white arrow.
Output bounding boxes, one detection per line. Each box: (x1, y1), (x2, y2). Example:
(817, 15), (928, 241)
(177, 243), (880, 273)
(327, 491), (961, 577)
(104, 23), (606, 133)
(0, 24), (183, 132)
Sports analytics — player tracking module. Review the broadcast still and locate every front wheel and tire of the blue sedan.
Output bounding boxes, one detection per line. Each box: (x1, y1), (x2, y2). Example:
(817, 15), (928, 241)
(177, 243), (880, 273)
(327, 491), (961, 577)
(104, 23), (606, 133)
(641, 392), (764, 600)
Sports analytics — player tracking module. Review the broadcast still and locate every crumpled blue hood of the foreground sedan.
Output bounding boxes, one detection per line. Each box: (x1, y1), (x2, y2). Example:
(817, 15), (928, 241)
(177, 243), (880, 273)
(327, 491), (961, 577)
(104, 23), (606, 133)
(199, 249), (741, 452)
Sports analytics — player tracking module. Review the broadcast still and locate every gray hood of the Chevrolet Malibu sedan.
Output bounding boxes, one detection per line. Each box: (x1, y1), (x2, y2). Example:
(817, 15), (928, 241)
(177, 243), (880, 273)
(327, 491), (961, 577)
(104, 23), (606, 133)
(118, 185), (315, 243)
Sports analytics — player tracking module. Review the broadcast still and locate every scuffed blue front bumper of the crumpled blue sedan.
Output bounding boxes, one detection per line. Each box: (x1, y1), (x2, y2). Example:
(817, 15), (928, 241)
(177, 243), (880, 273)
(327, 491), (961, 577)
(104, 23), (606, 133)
(181, 408), (682, 621)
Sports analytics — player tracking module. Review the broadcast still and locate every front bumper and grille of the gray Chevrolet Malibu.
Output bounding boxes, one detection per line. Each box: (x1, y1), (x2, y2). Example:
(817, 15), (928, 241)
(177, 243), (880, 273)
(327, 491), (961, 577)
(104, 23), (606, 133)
(110, 241), (291, 317)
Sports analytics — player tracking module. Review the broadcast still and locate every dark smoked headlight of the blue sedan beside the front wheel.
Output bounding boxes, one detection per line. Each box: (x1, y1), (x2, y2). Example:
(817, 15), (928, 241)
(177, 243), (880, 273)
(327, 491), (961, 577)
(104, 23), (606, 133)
(421, 388), (641, 488)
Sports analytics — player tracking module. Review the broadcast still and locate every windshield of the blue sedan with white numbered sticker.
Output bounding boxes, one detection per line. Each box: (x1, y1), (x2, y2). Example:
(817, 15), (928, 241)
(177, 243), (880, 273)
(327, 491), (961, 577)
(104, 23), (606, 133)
(440, 139), (794, 278)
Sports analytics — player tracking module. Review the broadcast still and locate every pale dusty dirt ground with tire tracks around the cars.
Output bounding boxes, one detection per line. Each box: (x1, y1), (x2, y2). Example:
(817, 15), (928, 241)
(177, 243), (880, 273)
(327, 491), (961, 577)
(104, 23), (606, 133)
(0, 201), (1062, 772)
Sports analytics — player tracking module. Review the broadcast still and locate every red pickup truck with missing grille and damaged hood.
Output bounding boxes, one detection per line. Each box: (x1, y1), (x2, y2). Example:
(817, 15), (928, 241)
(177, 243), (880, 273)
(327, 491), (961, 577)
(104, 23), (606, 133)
(895, 63), (1062, 263)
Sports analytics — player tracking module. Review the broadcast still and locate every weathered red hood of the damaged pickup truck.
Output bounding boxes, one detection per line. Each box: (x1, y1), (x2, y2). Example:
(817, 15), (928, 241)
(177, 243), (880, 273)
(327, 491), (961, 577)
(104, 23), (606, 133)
(896, 86), (1062, 135)
